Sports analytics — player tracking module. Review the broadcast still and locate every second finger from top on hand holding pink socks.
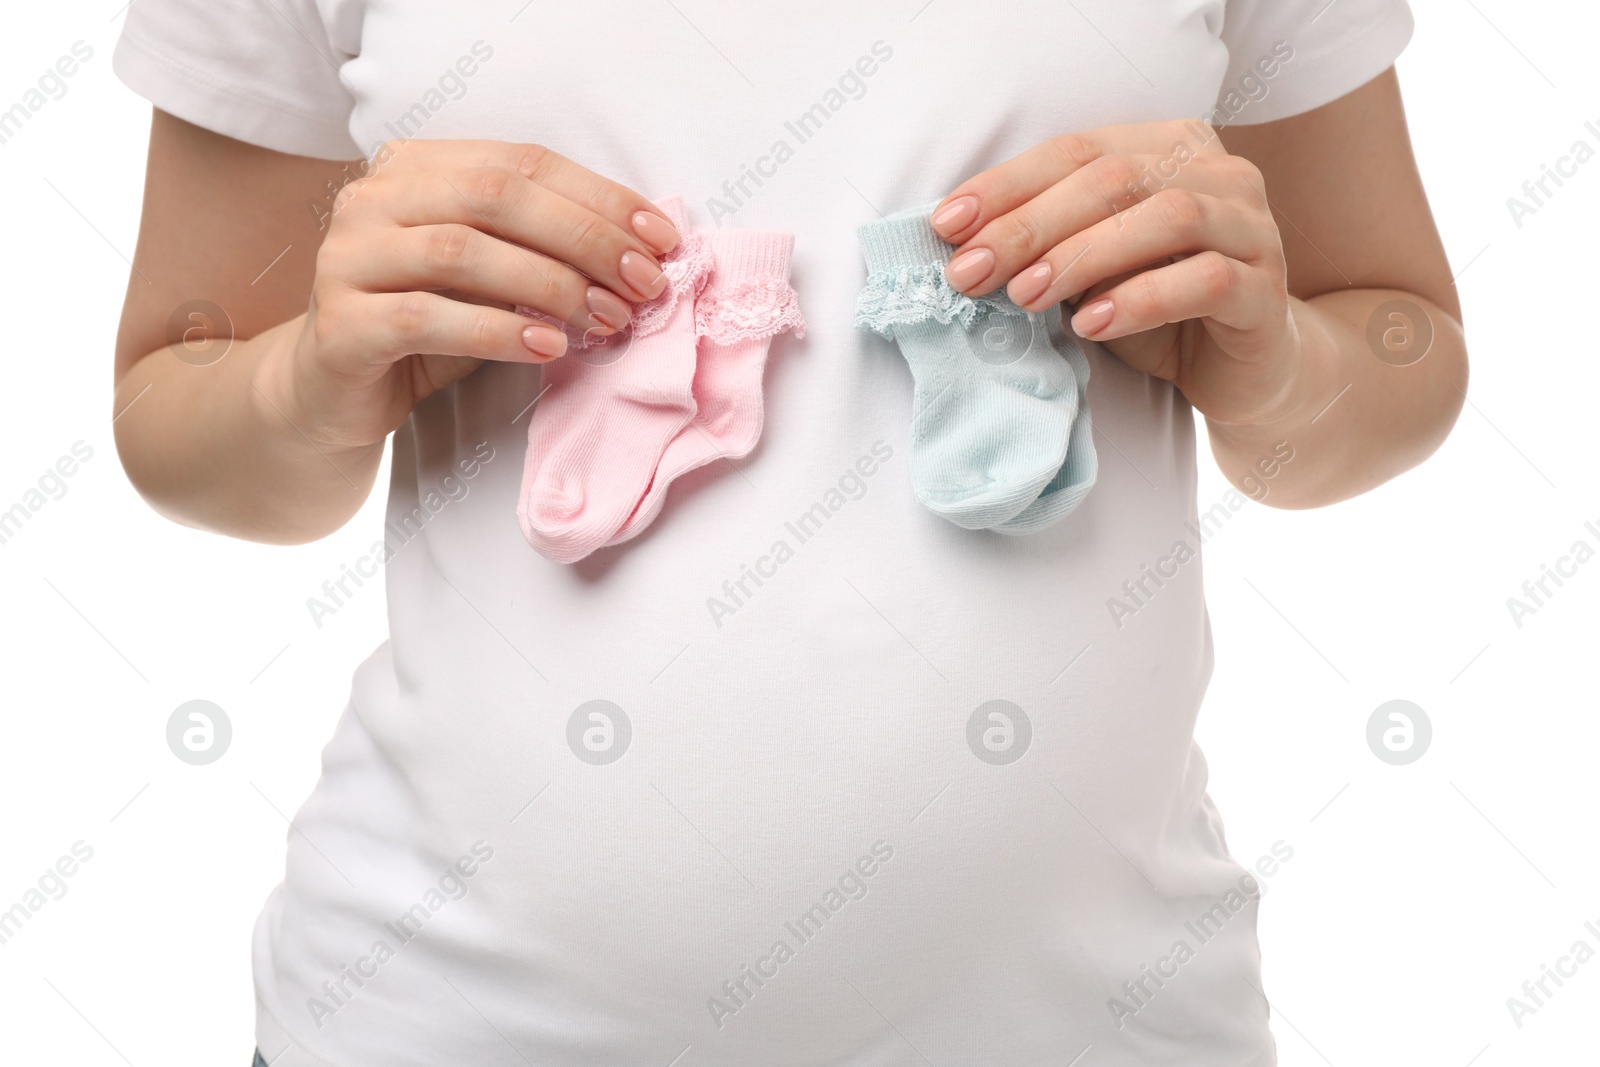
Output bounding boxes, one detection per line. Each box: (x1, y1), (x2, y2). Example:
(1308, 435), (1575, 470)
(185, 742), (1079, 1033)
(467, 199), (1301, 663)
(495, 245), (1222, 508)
(368, 166), (667, 301)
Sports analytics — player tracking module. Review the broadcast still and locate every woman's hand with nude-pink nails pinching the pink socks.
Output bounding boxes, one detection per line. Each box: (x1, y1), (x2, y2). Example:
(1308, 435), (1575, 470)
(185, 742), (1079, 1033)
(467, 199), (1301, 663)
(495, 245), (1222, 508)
(253, 141), (678, 450)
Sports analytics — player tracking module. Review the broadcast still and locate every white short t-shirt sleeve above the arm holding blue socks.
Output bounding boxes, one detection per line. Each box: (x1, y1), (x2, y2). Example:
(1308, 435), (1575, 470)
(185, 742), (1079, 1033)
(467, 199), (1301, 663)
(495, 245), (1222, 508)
(1210, 0), (1413, 125)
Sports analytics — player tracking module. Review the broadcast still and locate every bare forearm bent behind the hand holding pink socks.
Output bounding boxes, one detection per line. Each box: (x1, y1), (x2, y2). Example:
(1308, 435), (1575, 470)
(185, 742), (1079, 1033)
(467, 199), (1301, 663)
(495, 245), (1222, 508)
(114, 318), (384, 544)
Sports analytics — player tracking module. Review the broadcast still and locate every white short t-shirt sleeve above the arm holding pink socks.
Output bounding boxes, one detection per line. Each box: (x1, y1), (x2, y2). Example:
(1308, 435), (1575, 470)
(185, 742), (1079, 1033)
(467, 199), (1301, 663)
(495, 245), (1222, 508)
(112, 0), (363, 160)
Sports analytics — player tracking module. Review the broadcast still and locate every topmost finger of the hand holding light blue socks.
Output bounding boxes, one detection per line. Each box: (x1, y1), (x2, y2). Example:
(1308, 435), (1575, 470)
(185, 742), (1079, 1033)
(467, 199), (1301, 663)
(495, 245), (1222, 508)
(931, 122), (1224, 245)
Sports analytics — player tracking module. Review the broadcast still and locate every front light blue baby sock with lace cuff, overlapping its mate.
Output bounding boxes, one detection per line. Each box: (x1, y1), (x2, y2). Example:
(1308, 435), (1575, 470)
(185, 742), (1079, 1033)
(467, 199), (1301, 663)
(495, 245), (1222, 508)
(856, 205), (1086, 533)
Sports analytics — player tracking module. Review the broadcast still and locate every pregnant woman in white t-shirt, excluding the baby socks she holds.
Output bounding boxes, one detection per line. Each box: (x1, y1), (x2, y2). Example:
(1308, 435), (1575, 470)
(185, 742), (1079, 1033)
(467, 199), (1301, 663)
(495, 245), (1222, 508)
(115, 0), (1466, 1067)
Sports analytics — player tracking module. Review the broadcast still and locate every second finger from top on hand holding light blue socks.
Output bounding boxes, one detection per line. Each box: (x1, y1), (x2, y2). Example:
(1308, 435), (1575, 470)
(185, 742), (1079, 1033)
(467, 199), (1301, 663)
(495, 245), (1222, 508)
(946, 155), (1266, 294)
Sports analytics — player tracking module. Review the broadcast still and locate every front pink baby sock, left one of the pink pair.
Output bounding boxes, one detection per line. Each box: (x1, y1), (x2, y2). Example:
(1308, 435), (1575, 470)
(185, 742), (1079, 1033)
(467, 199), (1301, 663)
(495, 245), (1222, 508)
(517, 197), (710, 563)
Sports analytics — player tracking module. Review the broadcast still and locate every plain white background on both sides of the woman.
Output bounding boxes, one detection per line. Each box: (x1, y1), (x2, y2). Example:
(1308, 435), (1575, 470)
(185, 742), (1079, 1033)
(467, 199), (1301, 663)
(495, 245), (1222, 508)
(0, 0), (1600, 1067)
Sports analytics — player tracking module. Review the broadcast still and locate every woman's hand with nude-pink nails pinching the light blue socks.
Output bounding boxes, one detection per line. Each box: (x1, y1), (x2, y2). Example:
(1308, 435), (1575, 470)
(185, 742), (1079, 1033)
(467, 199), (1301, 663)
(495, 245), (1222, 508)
(933, 122), (1304, 424)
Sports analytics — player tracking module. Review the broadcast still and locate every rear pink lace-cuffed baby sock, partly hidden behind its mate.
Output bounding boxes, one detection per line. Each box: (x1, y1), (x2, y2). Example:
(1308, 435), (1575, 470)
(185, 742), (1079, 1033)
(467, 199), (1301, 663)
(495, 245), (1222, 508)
(608, 229), (805, 544)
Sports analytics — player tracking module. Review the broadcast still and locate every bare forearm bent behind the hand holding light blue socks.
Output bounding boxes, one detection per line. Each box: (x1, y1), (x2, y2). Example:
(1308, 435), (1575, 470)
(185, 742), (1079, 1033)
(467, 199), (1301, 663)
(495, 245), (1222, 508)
(1206, 290), (1467, 509)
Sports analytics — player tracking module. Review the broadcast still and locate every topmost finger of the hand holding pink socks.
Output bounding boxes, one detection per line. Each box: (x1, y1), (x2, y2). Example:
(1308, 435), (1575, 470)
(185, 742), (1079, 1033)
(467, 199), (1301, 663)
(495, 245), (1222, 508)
(374, 139), (680, 256)
